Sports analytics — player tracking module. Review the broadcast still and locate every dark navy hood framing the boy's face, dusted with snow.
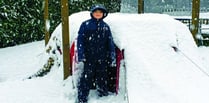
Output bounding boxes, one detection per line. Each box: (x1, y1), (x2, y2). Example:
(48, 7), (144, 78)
(90, 4), (108, 19)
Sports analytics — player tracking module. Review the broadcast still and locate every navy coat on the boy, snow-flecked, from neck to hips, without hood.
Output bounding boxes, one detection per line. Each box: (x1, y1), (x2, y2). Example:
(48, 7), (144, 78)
(77, 17), (115, 63)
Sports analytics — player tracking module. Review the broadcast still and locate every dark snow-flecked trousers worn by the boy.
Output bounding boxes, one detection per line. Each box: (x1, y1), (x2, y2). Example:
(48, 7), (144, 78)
(78, 61), (108, 103)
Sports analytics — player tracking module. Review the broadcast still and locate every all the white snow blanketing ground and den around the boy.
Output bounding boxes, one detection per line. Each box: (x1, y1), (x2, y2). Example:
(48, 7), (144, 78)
(0, 12), (209, 103)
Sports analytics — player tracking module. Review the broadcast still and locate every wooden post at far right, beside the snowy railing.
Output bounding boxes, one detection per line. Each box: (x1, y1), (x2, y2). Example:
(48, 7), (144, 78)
(191, 0), (200, 44)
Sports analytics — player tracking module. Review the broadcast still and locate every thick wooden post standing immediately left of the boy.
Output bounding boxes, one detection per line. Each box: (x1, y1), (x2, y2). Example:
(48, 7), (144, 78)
(61, 0), (72, 79)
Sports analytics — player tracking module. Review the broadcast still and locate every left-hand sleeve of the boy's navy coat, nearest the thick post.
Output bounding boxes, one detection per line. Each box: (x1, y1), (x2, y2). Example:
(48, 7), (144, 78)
(77, 23), (85, 62)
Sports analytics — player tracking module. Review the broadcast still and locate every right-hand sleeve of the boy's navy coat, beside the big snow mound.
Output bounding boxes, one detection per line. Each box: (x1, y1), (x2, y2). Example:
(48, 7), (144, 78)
(107, 26), (116, 63)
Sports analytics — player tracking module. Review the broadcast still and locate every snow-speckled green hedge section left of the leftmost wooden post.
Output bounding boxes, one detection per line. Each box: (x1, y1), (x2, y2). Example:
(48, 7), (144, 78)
(0, 0), (43, 47)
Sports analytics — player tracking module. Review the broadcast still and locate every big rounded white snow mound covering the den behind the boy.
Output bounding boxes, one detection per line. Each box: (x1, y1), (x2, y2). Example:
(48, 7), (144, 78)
(51, 12), (209, 103)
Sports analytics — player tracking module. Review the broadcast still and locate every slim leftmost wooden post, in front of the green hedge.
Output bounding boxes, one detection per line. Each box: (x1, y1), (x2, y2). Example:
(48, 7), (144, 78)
(44, 0), (49, 45)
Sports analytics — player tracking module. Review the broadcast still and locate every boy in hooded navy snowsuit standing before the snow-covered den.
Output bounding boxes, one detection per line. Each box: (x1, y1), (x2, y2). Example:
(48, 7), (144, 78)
(77, 4), (116, 103)
